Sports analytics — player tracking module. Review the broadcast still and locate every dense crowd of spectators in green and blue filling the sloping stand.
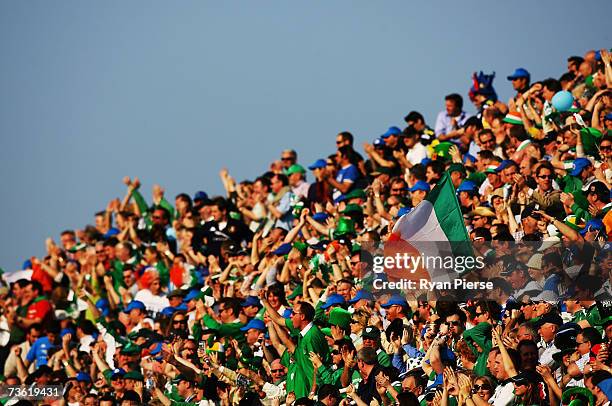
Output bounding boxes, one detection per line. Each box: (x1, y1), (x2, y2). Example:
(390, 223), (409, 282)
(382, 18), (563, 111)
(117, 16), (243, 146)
(0, 50), (612, 406)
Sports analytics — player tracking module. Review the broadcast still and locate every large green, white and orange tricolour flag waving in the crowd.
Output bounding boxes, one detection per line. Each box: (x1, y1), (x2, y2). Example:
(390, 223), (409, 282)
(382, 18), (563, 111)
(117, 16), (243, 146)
(385, 173), (473, 281)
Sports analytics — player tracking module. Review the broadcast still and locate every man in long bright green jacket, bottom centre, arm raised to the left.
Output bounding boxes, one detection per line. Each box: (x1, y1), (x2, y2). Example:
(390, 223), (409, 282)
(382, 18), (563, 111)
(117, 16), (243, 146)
(261, 295), (330, 399)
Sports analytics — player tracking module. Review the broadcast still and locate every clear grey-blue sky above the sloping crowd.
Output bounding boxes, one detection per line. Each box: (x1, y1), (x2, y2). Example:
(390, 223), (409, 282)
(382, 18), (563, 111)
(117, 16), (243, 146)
(0, 0), (612, 271)
